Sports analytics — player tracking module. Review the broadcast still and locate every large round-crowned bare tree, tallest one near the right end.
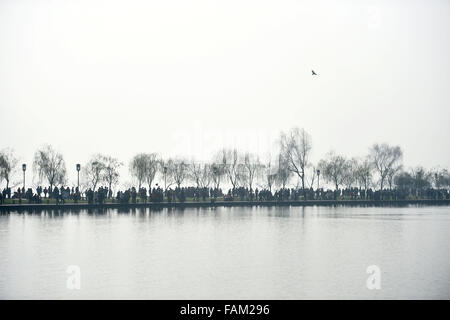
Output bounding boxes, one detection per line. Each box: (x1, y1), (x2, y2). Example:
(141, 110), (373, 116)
(369, 143), (403, 190)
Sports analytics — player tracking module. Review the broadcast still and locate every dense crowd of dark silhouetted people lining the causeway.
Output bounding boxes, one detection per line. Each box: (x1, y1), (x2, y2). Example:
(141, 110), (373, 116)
(0, 185), (450, 204)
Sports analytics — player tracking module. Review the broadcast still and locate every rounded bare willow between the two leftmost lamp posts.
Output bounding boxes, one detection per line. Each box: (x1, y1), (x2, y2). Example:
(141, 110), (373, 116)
(33, 145), (66, 191)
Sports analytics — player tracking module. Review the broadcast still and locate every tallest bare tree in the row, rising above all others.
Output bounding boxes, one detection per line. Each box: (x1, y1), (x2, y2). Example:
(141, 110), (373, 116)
(280, 128), (312, 189)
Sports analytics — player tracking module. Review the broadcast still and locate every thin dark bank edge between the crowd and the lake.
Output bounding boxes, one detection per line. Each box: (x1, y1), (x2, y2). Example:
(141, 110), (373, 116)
(0, 199), (450, 212)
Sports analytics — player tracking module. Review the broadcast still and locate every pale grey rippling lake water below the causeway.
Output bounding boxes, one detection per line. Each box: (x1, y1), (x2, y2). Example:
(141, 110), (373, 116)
(0, 206), (450, 299)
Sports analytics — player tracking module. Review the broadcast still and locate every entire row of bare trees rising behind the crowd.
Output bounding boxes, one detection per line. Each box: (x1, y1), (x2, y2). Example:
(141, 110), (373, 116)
(0, 128), (450, 190)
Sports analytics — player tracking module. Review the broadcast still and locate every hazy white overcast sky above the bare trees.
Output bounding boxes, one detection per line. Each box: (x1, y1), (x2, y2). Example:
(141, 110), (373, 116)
(0, 0), (450, 188)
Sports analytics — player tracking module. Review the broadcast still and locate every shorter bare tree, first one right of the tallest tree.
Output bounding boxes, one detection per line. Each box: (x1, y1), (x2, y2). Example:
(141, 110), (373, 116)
(319, 151), (348, 190)
